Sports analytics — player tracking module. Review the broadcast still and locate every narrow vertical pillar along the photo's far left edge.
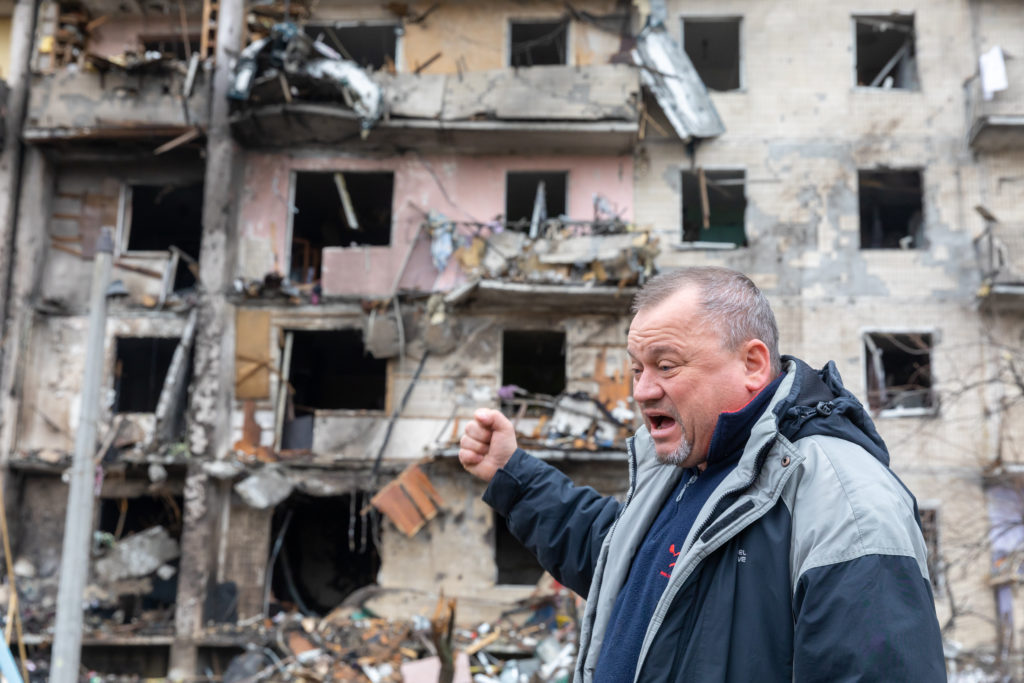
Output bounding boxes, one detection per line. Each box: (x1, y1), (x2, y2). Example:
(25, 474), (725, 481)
(0, 0), (38, 464)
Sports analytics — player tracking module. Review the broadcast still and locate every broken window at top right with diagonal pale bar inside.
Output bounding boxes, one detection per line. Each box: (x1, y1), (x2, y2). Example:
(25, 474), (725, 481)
(853, 14), (919, 90)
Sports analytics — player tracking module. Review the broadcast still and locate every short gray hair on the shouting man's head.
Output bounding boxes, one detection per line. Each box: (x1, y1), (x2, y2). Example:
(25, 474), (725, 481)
(632, 265), (782, 377)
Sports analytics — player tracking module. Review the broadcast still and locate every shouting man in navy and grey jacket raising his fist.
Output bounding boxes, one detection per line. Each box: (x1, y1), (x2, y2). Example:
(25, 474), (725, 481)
(459, 267), (945, 683)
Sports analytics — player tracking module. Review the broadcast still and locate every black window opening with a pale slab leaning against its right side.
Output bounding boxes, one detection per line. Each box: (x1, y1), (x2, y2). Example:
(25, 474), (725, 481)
(114, 337), (180, 413)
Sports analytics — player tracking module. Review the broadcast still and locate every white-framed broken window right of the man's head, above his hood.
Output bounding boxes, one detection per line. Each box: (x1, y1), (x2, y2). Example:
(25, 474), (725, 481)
(864, 332), (935, 415)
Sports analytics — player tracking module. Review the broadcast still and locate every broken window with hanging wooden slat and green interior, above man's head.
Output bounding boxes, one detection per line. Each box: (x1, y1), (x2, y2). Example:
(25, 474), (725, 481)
(683, 169), (746, 247)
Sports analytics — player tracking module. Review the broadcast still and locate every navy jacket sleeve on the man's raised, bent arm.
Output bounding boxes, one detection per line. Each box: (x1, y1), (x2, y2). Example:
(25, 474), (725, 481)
(483, 450), (620, 596)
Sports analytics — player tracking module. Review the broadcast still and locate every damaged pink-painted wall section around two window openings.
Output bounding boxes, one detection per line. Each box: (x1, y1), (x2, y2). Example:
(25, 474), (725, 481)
(240, 153), (633, 296)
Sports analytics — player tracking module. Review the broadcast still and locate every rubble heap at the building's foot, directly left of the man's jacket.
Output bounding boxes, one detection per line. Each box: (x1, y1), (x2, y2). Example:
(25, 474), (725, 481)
(205, 577), (581, 683)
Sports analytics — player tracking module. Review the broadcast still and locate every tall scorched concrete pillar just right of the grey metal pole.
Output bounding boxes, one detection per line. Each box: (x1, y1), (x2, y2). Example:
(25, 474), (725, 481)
(168, 0), (246, 680)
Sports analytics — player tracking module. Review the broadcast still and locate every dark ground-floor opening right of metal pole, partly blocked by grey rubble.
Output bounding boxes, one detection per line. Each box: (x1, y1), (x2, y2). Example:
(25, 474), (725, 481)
(98, 494), (184, 624)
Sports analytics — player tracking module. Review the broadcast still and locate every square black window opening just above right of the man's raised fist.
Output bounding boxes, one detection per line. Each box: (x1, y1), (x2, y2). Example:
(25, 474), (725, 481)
(502, 330), (565, 396)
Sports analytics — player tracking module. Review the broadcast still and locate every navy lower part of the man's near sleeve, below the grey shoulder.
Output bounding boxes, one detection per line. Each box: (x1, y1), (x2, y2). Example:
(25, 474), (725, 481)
(794, 554), (946, 683)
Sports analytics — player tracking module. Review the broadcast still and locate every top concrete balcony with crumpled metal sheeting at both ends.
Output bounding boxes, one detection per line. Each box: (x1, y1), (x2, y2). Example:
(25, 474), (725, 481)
(229, 18), (723, 152)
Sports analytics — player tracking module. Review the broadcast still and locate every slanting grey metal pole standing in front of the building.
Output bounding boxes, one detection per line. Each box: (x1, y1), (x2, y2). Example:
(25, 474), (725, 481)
(50, 227), (114, 683)
